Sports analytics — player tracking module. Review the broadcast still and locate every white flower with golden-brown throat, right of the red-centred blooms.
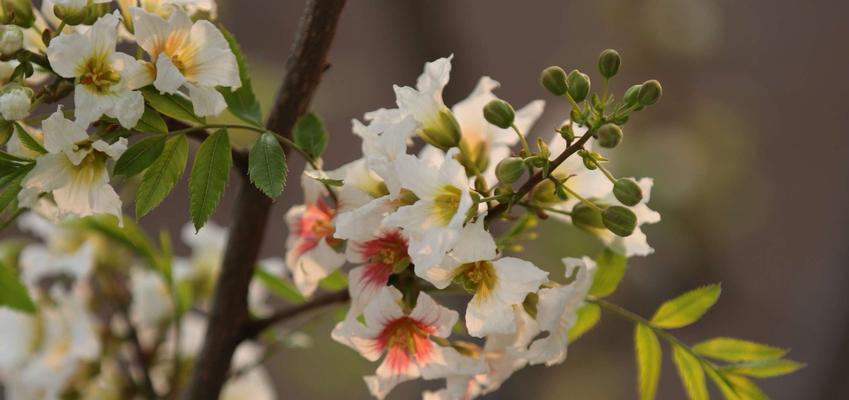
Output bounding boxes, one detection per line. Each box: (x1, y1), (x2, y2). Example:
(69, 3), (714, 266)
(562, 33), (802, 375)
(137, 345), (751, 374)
(416, 217), (548, 337)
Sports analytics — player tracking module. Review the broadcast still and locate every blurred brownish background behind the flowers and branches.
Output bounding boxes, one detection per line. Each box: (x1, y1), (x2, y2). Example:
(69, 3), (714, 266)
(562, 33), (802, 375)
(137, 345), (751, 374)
(11, 0), (849, 399)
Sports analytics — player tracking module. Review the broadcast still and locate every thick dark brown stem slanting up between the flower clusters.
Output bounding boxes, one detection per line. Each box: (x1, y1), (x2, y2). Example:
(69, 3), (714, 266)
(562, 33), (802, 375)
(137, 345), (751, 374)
(183, 0), (345, 400)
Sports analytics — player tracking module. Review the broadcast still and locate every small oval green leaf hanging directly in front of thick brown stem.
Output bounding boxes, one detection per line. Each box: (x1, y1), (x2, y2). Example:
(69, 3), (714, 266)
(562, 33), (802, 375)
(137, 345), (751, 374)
(248, 132), (287, 199)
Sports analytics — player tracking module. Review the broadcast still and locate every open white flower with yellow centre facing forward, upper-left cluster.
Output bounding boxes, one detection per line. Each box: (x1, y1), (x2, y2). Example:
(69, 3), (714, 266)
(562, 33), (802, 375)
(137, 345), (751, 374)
(47, 13), (150, 129)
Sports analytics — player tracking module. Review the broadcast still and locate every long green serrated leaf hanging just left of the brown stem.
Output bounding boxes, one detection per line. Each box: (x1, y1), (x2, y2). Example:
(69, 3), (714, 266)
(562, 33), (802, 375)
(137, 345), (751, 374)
(189, 129), (233, 230)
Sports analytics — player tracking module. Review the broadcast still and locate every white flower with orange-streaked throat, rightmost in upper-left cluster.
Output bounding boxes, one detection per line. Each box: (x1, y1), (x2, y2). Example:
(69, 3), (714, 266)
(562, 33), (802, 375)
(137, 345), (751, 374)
(131, 7), (242, 117)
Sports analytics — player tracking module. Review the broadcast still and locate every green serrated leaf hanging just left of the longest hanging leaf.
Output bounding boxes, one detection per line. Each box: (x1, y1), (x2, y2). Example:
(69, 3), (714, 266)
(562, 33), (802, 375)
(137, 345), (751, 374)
(136, 135), (189, 219)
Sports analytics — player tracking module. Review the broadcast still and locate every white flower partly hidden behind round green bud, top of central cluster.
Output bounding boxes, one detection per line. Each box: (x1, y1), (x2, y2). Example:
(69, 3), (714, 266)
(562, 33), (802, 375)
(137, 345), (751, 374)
(452, 76), (545, 185)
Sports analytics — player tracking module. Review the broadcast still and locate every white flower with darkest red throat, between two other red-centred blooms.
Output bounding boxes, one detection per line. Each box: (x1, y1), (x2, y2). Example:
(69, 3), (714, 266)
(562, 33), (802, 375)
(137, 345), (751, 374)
(347, 229), (410, 316)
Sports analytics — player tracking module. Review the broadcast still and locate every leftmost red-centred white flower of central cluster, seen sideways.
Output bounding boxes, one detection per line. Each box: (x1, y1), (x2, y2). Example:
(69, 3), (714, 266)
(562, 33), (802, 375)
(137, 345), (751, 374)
(286, 191), (345, 296)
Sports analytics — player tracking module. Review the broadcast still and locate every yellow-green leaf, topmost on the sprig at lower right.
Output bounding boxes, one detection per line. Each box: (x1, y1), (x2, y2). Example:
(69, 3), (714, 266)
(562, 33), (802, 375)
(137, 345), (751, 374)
(651, 285), (722, 328)
